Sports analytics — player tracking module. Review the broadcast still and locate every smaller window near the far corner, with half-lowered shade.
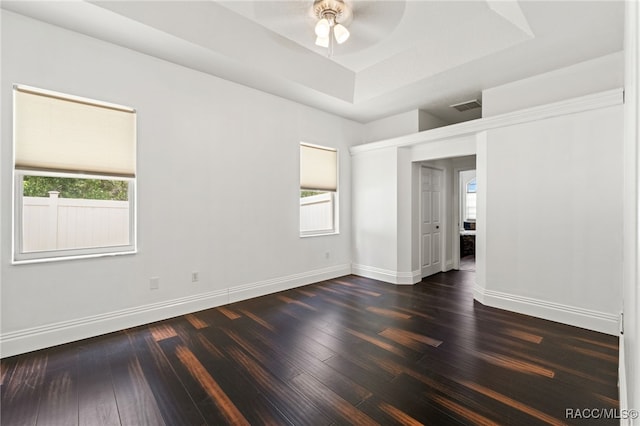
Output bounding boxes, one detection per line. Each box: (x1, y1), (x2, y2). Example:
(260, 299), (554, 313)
(300, 143), (338, 236)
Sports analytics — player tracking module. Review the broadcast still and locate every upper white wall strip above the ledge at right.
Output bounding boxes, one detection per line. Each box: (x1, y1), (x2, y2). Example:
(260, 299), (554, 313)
(482, 52), (624, 117)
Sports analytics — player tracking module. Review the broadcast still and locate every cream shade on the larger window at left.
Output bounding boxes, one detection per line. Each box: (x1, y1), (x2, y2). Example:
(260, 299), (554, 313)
(14, 86), (136, 177)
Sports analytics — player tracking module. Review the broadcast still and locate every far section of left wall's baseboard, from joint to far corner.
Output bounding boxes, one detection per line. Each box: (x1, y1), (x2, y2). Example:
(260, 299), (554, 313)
(229, 265), (351, 303)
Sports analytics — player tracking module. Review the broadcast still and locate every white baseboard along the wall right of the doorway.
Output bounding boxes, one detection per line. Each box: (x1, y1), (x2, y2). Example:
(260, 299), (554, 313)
(473, 286), (620, 336)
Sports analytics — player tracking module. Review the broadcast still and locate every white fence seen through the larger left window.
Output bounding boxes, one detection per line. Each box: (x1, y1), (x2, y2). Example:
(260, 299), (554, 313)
(22, 191), (129, 252)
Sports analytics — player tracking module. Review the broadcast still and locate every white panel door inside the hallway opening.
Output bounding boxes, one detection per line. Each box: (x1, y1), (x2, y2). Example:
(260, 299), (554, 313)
(420, 167), (442, 278)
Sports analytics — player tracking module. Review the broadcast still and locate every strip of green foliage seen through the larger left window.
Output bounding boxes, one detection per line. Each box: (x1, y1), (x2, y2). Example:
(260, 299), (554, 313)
(22, 176), (129, 201)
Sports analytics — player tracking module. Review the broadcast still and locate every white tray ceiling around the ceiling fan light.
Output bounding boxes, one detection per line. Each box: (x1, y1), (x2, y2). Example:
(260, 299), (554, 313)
(2, 0), (624, 123)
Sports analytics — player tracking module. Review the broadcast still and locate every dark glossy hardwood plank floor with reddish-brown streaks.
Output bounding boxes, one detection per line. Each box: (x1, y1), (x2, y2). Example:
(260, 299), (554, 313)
(0, 271), (618, 426)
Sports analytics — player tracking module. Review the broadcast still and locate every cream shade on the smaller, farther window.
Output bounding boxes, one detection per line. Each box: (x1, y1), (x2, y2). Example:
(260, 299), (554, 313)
(300, 144), (338, 191)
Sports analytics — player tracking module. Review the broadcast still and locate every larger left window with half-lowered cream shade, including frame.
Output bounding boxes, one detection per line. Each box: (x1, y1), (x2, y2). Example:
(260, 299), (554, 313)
(13, 86), (136, 262)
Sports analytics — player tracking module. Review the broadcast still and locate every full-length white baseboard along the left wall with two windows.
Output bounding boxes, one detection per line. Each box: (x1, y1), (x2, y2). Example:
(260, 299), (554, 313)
(0, 265), (351, 358)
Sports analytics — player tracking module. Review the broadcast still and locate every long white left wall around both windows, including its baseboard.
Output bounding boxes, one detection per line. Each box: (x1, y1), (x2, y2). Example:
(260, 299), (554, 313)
(0, 11), (362, 356)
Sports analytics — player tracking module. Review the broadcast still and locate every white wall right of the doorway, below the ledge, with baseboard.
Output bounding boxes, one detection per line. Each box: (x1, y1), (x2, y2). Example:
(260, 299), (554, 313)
(482, 105), (623, 334)
